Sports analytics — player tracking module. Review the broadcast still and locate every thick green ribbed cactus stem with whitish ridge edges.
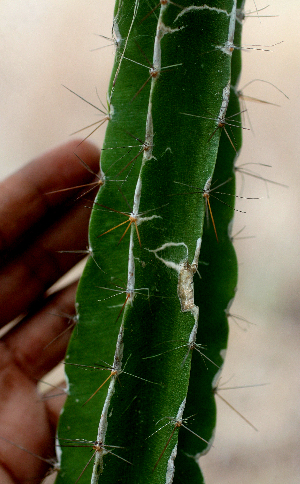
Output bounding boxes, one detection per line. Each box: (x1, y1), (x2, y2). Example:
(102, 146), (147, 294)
(56, 0), (243, 484)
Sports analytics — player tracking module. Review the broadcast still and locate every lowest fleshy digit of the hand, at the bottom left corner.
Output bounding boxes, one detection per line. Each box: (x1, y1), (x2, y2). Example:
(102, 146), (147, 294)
(0, 342), (55, 484)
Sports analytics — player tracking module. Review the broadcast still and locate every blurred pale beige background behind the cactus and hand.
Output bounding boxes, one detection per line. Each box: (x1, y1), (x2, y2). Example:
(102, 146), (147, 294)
(0, 0), (300, 484)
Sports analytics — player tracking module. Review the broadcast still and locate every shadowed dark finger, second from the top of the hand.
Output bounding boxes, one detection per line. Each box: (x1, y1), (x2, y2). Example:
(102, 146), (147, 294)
(0, 183), (96, 325)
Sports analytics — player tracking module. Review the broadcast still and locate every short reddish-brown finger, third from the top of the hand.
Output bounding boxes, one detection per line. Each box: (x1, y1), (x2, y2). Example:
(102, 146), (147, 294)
(3, 282), (77, 381)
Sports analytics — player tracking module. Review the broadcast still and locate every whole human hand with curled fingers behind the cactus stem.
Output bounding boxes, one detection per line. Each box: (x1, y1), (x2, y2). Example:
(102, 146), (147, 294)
(0, 141), (99, 484)
